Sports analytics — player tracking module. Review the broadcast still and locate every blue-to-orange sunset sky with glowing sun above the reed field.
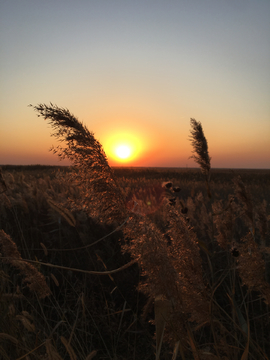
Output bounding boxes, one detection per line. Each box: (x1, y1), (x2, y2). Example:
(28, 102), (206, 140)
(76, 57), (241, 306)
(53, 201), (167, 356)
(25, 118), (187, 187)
(0, 0), (270, 169)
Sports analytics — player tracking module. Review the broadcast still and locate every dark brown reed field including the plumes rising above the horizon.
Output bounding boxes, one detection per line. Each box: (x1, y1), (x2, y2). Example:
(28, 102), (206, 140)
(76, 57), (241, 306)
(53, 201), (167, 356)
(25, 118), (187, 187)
(0, 104), (270, 360)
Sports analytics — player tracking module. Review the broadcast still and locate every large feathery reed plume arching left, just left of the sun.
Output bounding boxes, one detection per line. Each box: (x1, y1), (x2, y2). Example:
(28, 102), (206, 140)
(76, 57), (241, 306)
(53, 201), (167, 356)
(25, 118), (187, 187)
(30, 103), (125, 222)
